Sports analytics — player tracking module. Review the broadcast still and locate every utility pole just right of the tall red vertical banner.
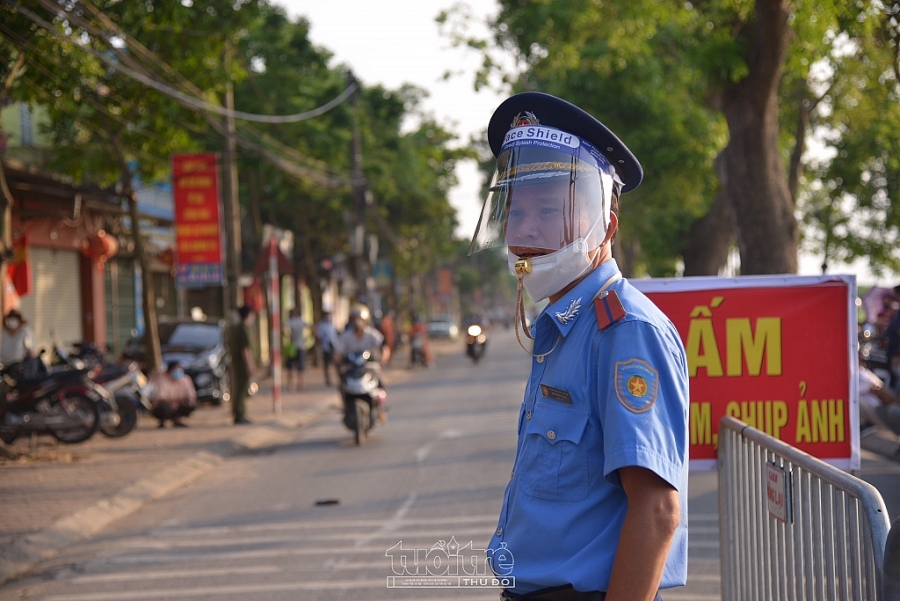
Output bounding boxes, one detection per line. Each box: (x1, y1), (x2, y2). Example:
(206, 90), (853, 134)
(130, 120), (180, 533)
(222, 75), (241, 319)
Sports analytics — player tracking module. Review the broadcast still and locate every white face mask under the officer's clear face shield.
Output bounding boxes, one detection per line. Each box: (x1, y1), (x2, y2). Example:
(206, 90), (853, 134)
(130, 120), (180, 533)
(507, 238), (594, 303)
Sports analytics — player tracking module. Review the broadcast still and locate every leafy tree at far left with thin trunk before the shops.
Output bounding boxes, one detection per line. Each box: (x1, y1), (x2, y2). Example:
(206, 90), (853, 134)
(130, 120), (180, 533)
(4, 0), (264, 368)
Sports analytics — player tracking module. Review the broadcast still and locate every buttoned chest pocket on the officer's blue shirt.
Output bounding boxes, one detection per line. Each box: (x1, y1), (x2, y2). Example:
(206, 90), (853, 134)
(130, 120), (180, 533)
(516, 402), (589, 501)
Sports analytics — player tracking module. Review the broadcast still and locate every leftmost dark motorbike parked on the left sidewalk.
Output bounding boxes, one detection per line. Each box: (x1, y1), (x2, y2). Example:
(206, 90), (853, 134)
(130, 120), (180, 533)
(0, 351), (100, 444)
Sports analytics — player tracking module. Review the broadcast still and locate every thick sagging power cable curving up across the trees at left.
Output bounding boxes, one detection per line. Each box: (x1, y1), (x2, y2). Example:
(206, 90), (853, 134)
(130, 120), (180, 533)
(8, 0), (359, 124)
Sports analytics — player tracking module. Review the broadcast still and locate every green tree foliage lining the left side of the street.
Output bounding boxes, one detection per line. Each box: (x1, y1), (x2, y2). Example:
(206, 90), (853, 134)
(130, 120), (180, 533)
(0, 0), (471, 350)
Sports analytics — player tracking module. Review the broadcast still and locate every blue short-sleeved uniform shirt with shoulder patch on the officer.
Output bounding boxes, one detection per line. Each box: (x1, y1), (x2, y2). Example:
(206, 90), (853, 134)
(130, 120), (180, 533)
(488, 260), (688, 594)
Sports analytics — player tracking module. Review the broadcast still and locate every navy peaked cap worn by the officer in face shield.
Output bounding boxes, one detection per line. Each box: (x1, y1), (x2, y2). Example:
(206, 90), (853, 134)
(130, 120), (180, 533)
(488, 92), (644, 193)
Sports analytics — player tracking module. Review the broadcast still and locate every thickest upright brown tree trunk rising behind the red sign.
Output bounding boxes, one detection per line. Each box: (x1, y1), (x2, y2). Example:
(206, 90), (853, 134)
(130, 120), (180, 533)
(722, 0), (799, 275)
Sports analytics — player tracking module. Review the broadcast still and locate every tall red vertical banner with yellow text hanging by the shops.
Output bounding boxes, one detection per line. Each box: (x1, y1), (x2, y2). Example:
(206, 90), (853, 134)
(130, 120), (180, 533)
(172, 153), (225, 288)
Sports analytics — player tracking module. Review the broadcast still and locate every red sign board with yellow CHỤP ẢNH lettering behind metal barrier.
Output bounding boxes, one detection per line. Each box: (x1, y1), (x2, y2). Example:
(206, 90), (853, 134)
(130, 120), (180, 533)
(632, 276), (859, 469)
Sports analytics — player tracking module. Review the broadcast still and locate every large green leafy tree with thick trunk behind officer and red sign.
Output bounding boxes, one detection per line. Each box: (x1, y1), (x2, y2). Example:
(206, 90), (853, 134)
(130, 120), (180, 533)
(444, 0), (898, 274)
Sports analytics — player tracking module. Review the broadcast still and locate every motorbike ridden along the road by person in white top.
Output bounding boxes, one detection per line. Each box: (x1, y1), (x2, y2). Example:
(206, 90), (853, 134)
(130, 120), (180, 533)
(339, 351), (387, 445)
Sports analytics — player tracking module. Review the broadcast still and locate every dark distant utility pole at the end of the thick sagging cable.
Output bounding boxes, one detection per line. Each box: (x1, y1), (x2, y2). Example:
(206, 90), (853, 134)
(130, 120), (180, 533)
(347, 71), (370, 302)
